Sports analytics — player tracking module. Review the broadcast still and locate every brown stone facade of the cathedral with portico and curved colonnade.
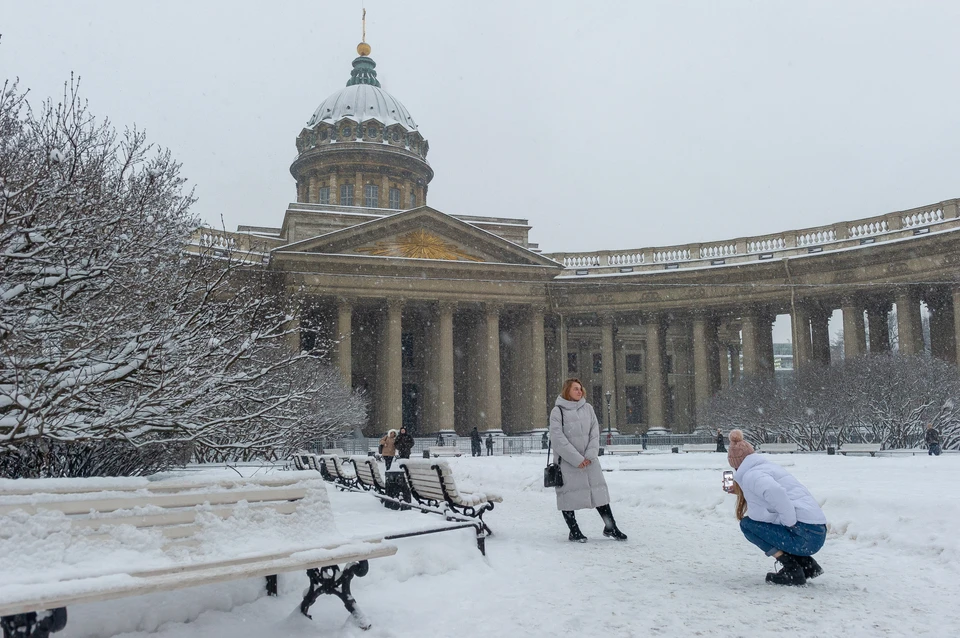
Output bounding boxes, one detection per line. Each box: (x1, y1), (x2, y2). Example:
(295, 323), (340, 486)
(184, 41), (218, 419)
(198, 46), (960, 435)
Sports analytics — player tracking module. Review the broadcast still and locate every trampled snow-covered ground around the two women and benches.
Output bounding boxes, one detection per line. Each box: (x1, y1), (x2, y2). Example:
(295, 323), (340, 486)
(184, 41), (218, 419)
(28, 454), (960, 638)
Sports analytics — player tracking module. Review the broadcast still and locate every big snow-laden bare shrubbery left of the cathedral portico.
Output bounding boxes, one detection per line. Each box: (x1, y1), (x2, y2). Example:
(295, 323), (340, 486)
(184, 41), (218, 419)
(0, 82), (363, 476)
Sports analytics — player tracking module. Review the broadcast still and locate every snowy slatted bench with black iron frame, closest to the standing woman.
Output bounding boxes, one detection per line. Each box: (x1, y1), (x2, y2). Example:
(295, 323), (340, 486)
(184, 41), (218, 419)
(400, 459), (503, 550)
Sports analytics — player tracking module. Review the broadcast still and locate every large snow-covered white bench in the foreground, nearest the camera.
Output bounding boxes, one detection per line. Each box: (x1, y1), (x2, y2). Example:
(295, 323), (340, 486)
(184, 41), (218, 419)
(0, 473), (397, 638)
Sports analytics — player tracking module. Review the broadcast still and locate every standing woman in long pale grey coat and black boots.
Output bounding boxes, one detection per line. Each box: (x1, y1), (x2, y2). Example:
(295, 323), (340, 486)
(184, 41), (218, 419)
(550, 379), (627, 543)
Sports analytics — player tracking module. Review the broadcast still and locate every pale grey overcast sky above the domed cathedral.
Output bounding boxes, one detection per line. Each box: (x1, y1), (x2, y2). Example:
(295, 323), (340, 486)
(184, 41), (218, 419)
(0, 0), (960, 252)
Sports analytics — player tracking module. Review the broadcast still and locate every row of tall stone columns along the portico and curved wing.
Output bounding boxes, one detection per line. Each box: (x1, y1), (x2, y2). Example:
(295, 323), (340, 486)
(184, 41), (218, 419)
(296, 287), (960, 435)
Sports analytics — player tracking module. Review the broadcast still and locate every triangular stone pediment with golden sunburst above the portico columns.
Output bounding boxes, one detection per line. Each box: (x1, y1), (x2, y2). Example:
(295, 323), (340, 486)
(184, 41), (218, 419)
(278, 206), (559, 266)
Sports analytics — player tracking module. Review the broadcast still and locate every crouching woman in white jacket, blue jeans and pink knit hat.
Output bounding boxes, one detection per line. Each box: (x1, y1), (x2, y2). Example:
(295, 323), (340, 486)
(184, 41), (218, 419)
(727, 430), (827, 585)
